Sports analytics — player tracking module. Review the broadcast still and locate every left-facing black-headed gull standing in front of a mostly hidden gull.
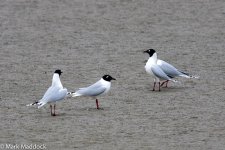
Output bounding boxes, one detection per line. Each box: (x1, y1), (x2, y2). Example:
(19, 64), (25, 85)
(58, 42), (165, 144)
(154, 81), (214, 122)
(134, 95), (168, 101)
(144, 49), (177, 91)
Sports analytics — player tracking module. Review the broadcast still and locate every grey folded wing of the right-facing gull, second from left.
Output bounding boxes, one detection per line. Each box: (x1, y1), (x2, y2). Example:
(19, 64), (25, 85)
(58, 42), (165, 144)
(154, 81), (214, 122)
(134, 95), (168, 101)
(76, 82), (106, 96)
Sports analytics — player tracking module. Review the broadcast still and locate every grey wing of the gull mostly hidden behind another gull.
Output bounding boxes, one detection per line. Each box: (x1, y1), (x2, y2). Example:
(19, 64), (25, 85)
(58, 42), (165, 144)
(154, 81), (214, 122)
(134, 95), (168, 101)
(157, 60), (183, 77)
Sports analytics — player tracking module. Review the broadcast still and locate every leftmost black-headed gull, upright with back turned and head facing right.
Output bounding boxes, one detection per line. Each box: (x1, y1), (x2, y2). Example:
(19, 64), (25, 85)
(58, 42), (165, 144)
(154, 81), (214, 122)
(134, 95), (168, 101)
(27, 70), (69, 116)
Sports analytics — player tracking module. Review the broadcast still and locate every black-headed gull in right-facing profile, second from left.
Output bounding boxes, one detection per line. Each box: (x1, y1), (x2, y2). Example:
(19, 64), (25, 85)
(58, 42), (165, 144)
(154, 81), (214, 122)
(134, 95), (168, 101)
(72, 75), (116, 109)
